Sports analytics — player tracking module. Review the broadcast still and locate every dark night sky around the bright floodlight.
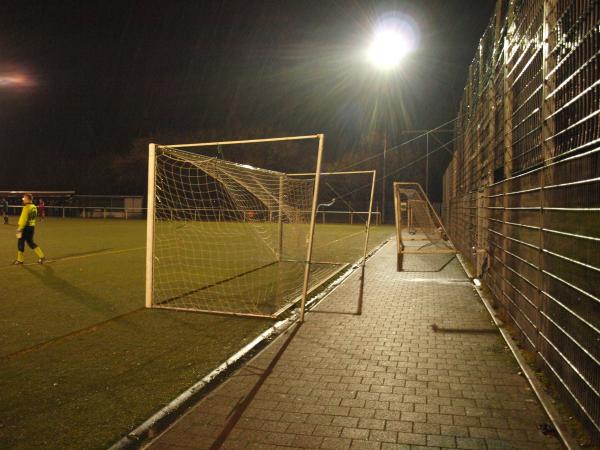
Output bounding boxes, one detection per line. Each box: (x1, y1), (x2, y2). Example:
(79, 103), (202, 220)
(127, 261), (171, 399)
(0, 0), (495, 199)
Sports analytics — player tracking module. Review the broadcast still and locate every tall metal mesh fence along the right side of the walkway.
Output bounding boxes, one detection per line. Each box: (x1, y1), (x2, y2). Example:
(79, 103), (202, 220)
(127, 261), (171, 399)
(443, 0), (600, 442)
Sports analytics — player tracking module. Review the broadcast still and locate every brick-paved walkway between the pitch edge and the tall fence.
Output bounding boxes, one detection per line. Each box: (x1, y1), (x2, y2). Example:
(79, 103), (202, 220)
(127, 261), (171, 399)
(151, 242), (563, 450)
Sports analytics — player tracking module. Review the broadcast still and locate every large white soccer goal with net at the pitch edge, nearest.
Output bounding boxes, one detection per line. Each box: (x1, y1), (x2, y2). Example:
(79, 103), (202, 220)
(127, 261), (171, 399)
(146, 135), (345, 317)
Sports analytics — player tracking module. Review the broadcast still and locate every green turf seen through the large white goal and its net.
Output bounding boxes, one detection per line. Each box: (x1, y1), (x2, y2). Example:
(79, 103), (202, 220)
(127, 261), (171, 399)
(154, 221), (382, 315)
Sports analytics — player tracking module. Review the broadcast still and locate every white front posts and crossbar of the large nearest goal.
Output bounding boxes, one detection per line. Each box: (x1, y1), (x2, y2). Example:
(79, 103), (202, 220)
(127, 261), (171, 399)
(145, 133), (325, 322)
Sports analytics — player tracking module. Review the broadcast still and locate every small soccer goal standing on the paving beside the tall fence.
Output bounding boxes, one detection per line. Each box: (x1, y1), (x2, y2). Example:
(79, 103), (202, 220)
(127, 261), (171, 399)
(394, 182), (456, 272)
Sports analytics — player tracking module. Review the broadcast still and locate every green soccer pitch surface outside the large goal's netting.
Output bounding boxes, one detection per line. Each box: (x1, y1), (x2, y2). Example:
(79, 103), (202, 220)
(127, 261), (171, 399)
(0, 217), (393, 449)
